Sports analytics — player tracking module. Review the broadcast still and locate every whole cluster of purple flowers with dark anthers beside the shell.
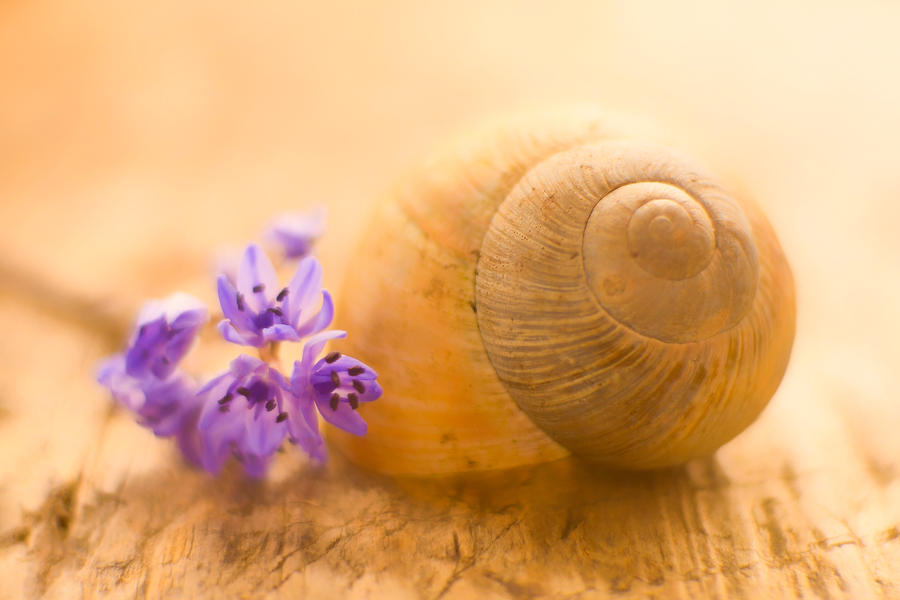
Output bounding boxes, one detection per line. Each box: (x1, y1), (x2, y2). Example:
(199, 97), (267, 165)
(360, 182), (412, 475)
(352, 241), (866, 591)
(97, 212), (381, 477)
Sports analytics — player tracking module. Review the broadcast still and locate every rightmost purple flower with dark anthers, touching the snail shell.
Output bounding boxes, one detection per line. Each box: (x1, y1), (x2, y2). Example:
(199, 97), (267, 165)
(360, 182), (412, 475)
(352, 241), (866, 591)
(288, 330), (381, 435)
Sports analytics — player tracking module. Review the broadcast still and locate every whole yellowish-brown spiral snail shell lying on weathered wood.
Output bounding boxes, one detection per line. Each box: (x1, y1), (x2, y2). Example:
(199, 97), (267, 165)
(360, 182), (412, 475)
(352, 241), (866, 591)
(329, 108), (795, 474)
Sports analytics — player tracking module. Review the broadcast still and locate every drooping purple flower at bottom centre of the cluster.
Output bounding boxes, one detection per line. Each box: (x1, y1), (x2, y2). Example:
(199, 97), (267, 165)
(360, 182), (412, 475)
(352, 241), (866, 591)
(197, 354), (300, 477)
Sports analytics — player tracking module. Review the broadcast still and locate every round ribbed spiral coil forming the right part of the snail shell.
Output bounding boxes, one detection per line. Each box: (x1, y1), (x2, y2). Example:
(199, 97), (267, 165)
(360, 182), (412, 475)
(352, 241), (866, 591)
(475, 142), (793, 467)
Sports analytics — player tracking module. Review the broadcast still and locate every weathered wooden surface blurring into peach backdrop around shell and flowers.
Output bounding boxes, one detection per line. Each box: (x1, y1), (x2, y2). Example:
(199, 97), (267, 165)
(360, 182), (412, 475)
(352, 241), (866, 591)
(0, 0), (900, 598)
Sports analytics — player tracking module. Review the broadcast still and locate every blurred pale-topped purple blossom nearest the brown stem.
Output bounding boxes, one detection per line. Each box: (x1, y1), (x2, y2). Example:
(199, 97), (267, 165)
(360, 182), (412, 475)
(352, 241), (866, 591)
(125, 293), (209, 379)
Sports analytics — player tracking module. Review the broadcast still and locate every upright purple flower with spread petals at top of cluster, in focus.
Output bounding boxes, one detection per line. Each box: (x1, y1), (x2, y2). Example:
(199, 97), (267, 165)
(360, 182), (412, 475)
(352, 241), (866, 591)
(217, 244), (334, 348)
